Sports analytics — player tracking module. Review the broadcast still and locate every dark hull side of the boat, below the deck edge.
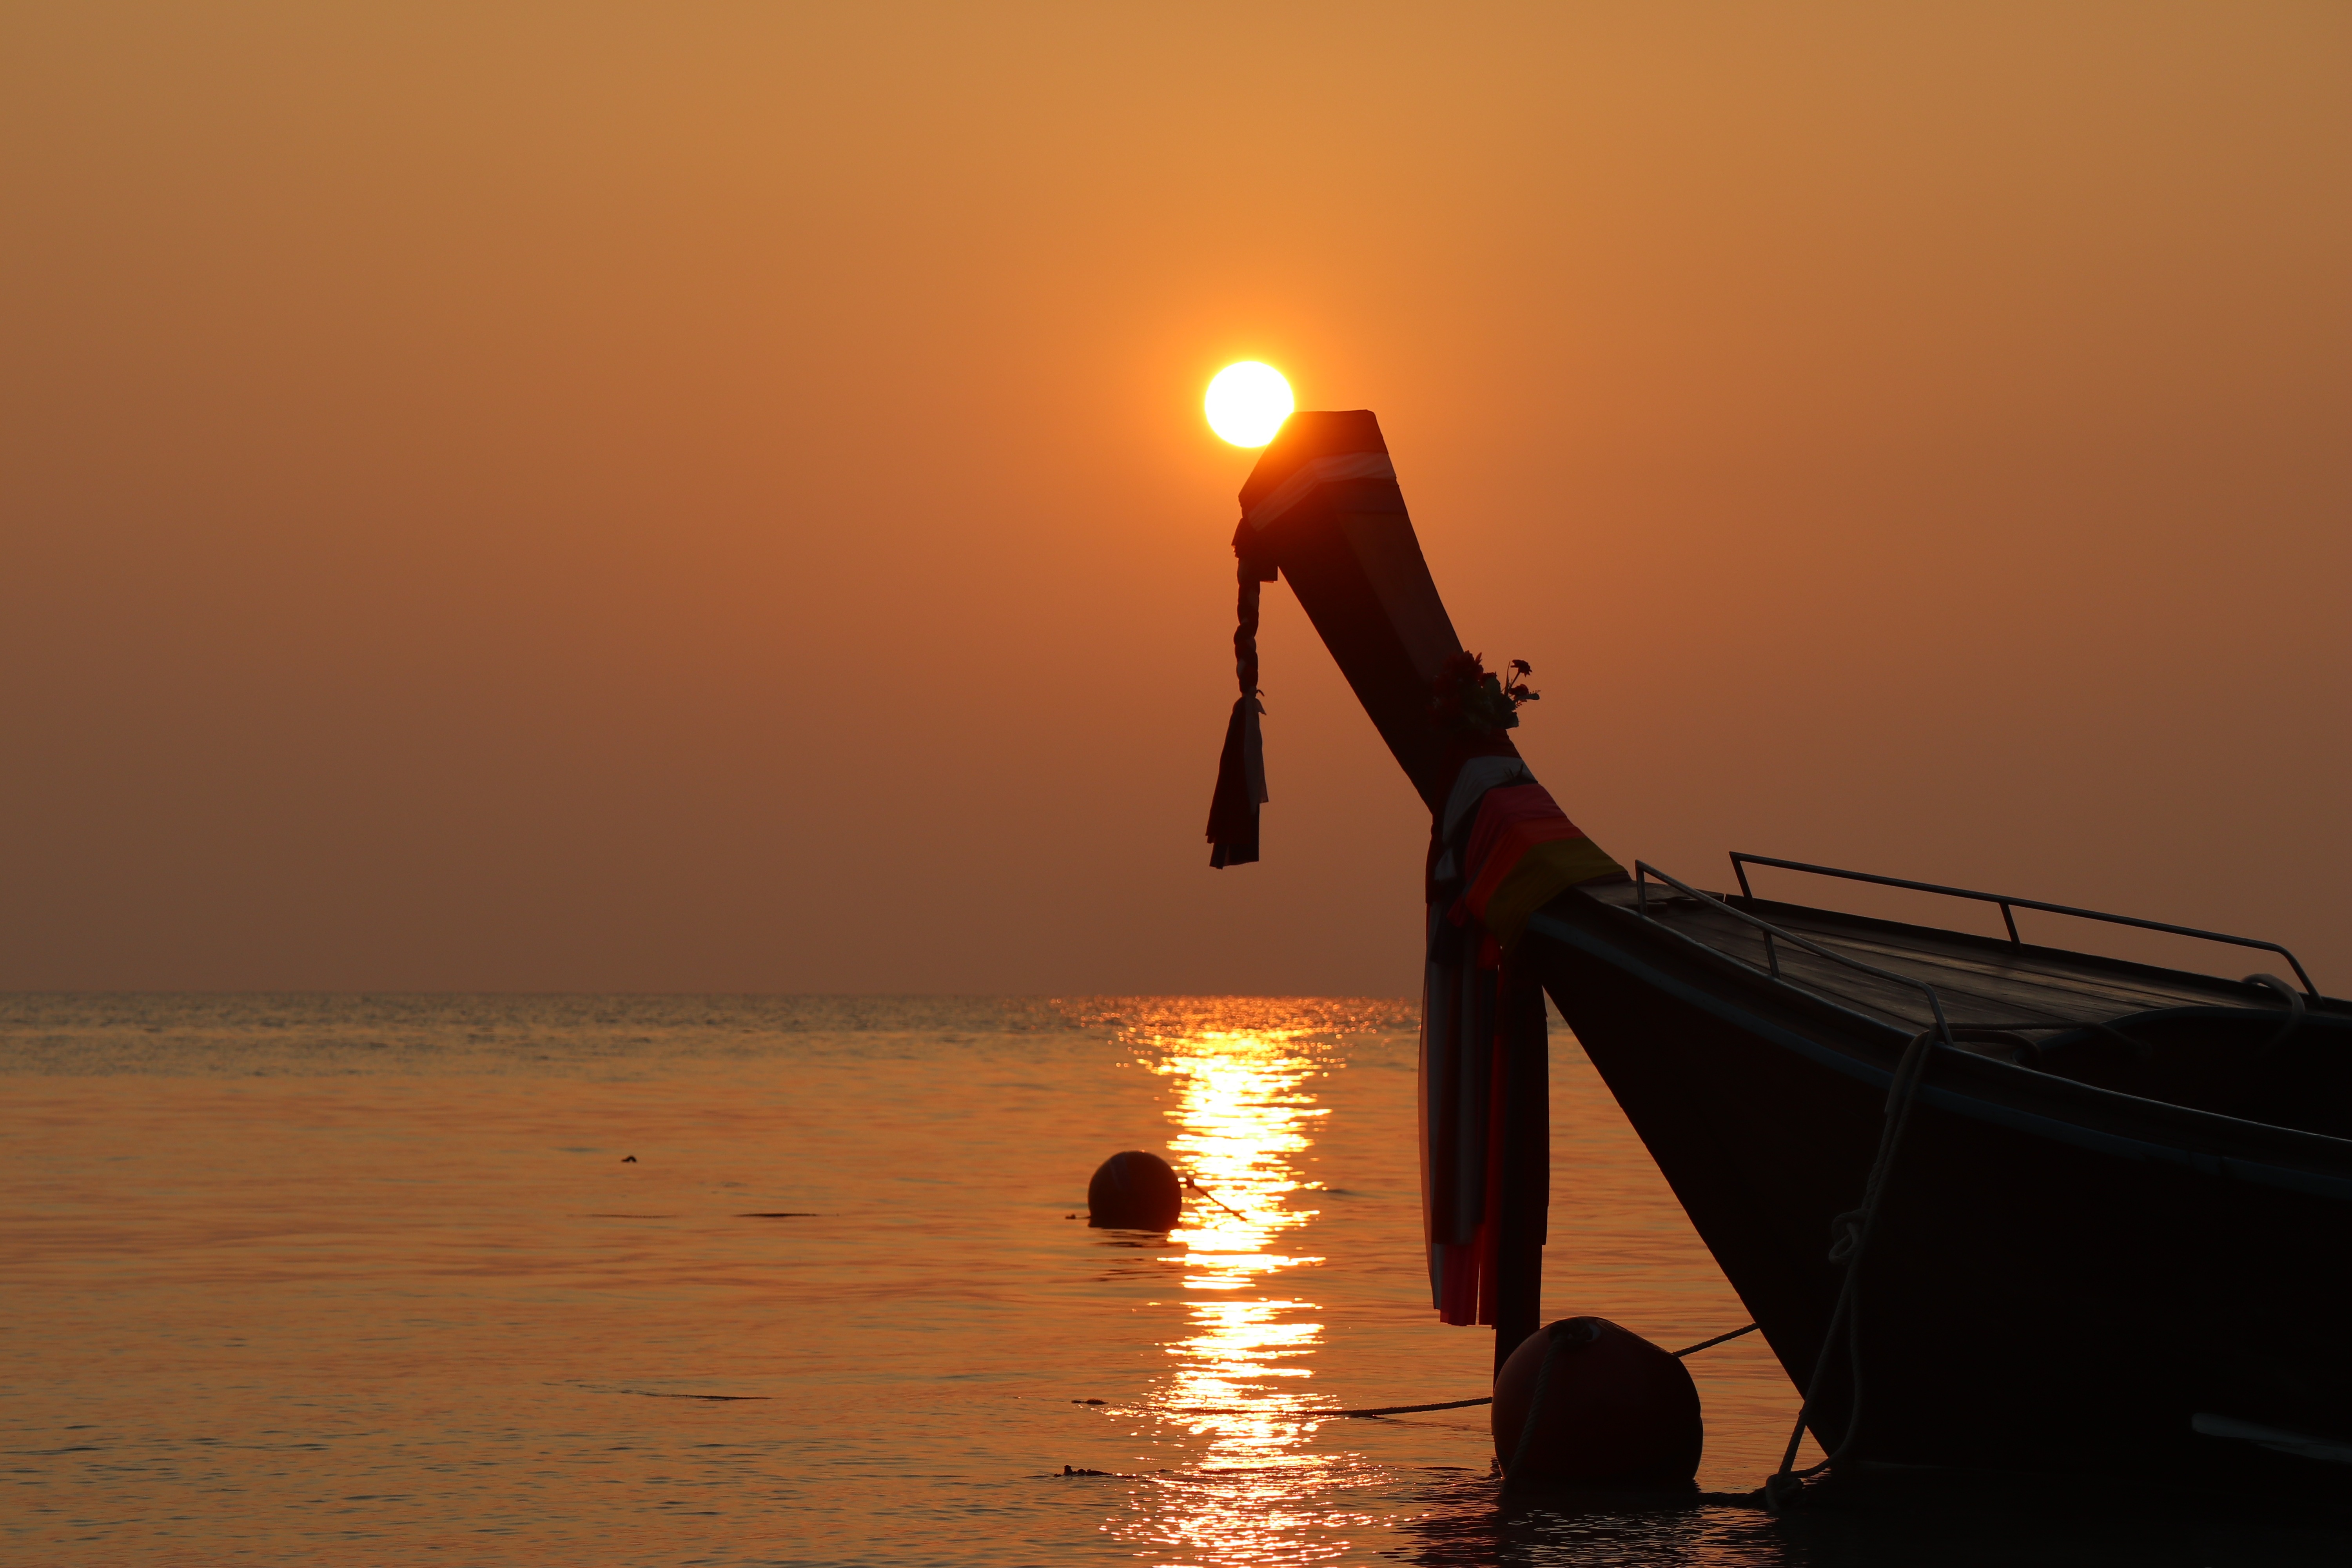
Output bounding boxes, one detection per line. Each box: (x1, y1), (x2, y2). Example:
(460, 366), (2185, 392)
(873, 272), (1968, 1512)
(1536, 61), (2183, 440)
(1524, 893), (2352, 1493)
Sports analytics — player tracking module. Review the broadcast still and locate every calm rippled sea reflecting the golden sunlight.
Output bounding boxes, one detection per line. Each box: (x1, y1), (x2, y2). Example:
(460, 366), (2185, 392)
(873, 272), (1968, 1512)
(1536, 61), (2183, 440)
(0, 997), (2343, 1563)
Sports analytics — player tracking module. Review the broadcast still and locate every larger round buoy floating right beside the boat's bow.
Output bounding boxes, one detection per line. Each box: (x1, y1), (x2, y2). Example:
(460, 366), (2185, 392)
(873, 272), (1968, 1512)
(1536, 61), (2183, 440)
(1494, 1316), (1705, 1486)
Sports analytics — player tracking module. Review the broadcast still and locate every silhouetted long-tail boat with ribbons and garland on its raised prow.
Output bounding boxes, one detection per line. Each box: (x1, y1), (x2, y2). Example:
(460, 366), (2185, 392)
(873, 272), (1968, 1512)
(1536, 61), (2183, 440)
(1209, 411), (2352, 1500)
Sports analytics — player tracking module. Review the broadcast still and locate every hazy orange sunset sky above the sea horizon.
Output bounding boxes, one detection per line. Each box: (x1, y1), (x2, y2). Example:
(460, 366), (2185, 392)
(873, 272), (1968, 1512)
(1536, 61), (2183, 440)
(0, 0), (2352, 995)
